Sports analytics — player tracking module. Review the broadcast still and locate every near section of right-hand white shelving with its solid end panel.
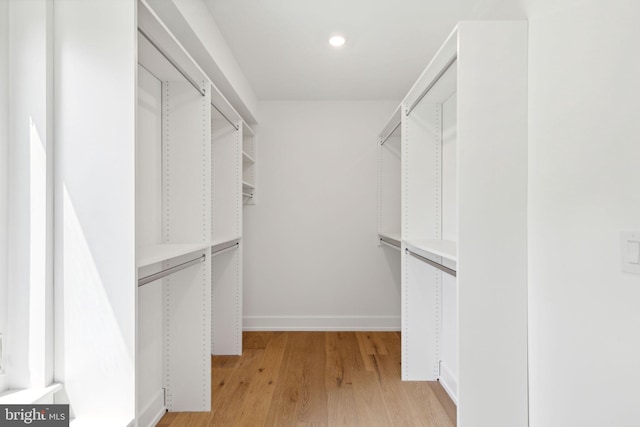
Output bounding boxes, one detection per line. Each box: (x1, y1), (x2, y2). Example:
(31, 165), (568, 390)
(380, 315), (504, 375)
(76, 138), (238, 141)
(398, 21), (527, 427)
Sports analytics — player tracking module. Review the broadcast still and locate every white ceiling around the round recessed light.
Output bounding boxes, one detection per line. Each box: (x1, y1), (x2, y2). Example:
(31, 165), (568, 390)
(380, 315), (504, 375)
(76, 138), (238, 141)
(205, 0), (459, 100)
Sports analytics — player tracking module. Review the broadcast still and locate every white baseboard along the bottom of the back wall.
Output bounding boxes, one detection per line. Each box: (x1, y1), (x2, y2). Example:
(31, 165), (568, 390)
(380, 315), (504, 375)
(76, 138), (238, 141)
(243, 316), (400, 331)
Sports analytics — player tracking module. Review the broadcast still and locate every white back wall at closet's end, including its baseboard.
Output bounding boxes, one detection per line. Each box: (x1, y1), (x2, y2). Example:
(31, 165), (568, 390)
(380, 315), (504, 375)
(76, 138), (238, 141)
(243, 101), (400, 330)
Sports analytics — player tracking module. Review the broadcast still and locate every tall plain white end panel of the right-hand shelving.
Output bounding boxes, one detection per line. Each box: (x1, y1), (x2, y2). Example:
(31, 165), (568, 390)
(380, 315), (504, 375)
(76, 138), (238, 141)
(457, 21), (528, 427)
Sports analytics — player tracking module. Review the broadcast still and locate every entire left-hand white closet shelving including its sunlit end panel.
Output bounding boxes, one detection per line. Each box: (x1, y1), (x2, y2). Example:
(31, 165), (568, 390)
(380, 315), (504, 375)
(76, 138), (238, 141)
(54, 0), (255, 427)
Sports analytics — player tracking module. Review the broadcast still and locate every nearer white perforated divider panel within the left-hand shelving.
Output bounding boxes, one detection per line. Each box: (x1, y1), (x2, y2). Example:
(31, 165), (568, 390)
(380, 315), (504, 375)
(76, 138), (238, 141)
(162, 81), (211, 411)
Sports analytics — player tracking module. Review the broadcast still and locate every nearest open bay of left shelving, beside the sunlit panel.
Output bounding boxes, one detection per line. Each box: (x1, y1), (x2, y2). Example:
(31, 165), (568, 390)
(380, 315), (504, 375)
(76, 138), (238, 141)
(136, 2), (212, 426)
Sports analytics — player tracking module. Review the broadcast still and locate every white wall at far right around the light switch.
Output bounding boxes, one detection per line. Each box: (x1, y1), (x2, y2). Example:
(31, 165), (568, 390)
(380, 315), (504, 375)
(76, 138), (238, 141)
(469, 0), (640, 427)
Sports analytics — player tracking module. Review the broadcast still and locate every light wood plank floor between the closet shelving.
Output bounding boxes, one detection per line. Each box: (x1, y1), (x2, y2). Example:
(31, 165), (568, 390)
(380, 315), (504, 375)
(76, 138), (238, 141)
(158, 332), (456, 427)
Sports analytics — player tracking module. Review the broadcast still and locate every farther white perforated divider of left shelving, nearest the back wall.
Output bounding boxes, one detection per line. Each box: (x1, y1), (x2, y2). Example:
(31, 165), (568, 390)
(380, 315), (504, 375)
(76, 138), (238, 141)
(211, 111), (243, 355)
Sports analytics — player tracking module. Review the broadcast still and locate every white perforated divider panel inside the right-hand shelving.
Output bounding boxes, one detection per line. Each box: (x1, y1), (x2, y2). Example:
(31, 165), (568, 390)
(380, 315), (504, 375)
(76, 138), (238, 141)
(401, 102), (441, 380)
